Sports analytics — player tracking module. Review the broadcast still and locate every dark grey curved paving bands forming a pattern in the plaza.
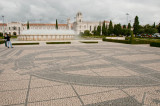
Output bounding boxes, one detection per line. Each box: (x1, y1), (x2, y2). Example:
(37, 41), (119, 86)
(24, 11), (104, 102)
(17, 46), (160, 86)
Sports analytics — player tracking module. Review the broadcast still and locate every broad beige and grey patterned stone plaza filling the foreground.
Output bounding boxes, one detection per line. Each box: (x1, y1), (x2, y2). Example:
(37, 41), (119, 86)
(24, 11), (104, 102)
(0, 42), (160, 106)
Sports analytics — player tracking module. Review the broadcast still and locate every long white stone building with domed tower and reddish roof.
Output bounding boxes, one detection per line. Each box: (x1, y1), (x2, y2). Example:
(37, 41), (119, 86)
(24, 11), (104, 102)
(0, 12), (109, 35)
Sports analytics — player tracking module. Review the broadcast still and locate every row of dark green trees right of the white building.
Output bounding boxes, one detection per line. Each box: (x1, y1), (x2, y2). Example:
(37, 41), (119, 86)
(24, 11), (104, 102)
(83, 16), (160, 36)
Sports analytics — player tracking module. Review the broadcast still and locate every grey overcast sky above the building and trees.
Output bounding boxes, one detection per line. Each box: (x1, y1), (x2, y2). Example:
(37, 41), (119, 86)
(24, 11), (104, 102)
(0, 0), (160, 25)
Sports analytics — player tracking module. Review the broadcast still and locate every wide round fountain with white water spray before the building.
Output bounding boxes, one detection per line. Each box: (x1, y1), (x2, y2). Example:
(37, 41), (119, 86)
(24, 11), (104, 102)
(18, 29), (75, 41)
